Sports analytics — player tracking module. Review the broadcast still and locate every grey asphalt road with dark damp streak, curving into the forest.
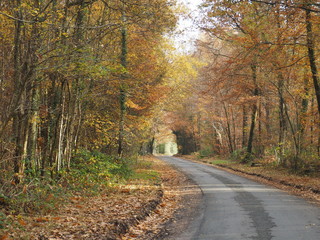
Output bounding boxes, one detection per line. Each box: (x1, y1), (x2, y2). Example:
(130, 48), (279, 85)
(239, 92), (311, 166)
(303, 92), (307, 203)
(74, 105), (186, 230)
(160, 157), (320, 240)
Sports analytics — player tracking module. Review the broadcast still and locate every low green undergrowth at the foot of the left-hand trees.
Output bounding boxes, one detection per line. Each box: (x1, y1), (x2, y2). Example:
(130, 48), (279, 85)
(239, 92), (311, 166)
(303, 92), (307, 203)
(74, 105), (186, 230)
(0, 150), (159, 232)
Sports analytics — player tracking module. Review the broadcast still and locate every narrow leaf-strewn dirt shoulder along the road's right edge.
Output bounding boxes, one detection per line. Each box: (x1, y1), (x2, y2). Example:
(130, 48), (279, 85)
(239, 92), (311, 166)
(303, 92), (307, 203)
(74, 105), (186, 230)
(181, 155), (320, 205)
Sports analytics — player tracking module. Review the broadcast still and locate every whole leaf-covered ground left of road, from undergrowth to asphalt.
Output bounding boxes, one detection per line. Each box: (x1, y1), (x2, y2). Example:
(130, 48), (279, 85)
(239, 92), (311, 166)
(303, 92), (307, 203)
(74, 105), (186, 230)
(0, 157), (198, 240)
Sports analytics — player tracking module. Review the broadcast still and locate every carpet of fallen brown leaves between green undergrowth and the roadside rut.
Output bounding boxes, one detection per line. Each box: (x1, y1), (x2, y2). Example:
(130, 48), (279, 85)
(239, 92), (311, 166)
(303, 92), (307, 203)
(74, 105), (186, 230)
(10, 185), (159, 240)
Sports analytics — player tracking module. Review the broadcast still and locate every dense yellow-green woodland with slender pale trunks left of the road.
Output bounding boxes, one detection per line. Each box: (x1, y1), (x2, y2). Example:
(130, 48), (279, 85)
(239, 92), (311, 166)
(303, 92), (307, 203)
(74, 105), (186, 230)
(0, 0), (177, 183)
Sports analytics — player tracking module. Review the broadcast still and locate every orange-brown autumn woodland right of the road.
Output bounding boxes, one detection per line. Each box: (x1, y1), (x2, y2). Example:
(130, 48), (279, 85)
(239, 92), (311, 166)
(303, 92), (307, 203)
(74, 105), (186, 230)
(172, 0), (320, 172)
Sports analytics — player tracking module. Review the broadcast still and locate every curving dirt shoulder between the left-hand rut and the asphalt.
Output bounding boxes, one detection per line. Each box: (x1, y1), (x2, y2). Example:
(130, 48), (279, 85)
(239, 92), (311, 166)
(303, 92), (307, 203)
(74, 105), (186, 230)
(122, 158), (202, 240)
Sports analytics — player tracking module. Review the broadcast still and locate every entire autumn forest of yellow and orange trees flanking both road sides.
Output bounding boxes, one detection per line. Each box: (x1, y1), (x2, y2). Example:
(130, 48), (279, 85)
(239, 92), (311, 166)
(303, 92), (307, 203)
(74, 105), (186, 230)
(0, 0), (320, 239)
